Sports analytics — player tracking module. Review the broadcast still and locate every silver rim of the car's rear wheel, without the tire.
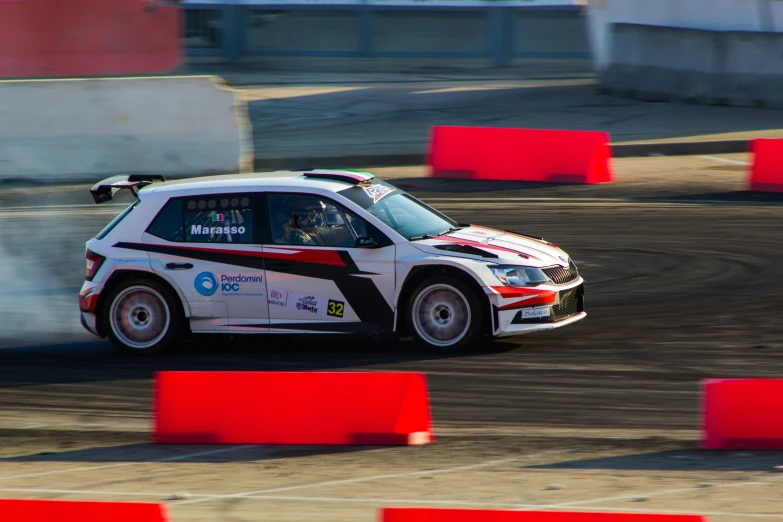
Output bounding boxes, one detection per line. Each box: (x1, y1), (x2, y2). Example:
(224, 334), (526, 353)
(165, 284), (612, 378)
(110, 285), (171, 350)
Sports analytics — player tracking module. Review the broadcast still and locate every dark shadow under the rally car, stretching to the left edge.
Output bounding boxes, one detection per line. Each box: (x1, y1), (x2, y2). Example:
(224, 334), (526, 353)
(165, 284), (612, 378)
(0, 335), (518, 388)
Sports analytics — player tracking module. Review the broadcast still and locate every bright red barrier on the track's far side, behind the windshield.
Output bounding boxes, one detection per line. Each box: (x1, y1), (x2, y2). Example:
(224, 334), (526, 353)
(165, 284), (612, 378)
(429, 127), (614, 184)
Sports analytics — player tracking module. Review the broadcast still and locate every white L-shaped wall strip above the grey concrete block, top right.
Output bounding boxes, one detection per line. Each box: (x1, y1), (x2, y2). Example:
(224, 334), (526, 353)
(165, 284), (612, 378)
(588, 0), (783, 71)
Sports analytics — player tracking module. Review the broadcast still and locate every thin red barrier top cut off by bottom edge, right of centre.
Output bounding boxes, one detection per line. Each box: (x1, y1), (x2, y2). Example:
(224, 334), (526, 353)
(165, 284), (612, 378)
(379, 508), (707, 522)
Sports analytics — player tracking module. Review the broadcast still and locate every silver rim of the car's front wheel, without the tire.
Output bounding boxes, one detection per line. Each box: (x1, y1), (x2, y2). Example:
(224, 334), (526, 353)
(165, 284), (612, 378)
(413, 284), (470, 347)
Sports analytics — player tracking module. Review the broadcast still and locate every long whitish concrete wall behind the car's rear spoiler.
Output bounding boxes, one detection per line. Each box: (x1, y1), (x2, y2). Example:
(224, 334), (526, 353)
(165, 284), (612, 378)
(0, 77), (252, 182)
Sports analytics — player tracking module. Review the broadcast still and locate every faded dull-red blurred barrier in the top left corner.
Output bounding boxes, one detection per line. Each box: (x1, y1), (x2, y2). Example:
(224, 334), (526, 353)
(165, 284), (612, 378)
(0, 0), (182, 78)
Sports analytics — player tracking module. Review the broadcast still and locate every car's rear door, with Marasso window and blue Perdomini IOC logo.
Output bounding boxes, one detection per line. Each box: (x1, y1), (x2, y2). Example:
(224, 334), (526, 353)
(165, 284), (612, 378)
(143, 193), (269, 332)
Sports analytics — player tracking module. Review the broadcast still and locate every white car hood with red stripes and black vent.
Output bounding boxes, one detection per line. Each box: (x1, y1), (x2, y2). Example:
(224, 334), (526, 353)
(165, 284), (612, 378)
(411, 226), (570, 267)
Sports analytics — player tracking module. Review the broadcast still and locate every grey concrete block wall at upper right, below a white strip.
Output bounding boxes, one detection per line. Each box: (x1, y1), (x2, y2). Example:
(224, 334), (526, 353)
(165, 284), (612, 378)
(600, 24), (783, 107)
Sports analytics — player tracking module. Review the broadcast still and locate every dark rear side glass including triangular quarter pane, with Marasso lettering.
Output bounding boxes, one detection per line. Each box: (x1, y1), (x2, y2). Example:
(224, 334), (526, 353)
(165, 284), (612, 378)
(147, 194), (255, 244)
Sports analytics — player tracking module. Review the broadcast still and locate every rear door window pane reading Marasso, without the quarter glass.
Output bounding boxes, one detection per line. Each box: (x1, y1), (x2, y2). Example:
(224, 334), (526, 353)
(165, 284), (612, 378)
(182, 194), (254, 243)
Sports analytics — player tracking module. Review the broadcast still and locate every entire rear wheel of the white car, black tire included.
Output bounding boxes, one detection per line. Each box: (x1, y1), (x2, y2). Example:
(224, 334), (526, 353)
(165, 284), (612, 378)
(101, 277), (184, 355)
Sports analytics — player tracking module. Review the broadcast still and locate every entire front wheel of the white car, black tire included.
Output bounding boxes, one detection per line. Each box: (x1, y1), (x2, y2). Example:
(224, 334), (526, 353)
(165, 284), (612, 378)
(405, 275), (485, 353)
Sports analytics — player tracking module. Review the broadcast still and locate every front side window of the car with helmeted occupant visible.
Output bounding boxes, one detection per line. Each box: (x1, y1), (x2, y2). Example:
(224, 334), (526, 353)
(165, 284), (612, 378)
(269, 194), (380, 248)
